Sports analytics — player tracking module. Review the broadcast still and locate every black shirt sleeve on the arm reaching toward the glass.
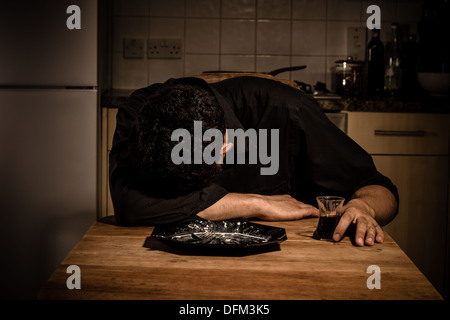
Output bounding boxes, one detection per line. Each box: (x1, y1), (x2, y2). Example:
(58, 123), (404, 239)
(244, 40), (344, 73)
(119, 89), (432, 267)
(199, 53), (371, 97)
(298, 96), (399, 203)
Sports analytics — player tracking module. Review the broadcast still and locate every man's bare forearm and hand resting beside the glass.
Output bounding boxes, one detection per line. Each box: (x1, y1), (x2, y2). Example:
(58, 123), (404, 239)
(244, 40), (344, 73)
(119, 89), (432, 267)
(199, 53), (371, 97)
(333, 185), (397, 246)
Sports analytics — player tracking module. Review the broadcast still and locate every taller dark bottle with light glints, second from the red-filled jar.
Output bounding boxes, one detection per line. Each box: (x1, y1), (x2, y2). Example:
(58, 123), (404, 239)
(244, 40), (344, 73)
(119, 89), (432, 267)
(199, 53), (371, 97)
(384, 23), (402, 96)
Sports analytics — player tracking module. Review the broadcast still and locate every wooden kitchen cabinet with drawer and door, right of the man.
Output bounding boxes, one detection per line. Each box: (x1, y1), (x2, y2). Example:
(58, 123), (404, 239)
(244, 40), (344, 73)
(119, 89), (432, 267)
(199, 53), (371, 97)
(347, 112), (450, 296)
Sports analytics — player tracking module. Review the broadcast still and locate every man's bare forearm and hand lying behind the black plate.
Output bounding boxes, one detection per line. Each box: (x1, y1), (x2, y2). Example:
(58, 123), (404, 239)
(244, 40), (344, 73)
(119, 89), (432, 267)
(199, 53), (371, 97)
(197, 193), (319, 221)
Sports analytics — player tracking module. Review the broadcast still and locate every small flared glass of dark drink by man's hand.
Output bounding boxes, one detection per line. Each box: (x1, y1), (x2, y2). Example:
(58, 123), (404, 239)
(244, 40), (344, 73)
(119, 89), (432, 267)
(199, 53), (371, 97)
(314, 196), (345, 241)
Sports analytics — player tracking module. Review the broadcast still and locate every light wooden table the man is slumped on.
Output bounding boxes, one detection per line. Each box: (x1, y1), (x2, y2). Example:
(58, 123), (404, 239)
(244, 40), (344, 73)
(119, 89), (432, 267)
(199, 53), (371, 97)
(38, 218), (442, 300)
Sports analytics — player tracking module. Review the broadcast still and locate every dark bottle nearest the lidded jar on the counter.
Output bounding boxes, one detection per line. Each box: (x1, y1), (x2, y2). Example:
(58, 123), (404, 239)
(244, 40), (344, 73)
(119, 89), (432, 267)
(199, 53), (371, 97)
(367, 29), (384, 98)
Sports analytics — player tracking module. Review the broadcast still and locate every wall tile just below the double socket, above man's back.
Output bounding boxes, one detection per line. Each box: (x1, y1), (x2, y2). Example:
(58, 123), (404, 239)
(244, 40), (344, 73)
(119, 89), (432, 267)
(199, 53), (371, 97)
(148, 59), (184, 84)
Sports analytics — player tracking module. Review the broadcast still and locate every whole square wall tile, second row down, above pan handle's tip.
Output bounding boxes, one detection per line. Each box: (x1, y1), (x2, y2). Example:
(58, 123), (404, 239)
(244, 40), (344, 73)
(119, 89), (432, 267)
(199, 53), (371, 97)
(292, 21), (326, 55)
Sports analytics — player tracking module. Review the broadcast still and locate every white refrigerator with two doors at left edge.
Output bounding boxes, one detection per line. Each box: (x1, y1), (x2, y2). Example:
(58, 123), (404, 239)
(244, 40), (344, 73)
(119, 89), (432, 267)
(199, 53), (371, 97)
(0, 0), (99, 299)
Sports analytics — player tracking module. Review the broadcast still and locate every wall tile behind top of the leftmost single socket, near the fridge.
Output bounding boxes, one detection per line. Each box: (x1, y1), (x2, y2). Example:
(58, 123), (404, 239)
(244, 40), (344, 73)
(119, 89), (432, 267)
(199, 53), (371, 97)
(113, 16), (148, 52)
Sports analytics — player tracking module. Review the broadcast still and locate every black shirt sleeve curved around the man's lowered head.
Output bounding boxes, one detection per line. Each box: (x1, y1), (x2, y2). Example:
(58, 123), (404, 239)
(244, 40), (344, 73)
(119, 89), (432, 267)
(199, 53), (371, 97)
(109, 84), (228, 225)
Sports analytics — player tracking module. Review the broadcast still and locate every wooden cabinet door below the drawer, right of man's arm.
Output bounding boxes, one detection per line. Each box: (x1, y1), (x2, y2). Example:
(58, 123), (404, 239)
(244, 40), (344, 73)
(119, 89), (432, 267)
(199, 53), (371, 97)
(373, 155), (449, 292)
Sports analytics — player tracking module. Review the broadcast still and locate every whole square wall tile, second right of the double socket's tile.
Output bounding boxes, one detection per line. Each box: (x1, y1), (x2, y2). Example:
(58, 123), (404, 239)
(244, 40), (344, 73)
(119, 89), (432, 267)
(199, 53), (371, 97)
(220, 20), (256, 54)
